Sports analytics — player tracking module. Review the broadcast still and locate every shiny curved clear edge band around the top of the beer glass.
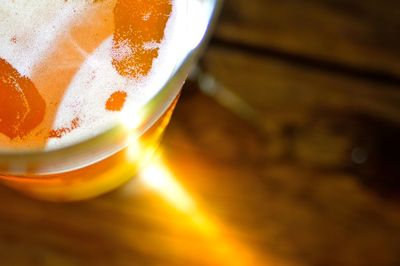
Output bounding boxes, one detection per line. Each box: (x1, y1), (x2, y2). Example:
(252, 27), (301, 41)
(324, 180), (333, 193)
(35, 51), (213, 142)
(0, 0), (223, 176)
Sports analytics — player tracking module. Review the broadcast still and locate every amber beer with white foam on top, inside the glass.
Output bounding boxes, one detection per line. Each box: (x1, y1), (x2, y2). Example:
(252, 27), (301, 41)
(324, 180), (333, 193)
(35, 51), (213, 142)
(0, 0), (195, 201)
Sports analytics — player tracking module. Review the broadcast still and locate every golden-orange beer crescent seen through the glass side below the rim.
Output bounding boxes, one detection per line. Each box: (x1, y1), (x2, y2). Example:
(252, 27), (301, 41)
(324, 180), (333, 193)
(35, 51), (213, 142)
(0, 99), (178, 201)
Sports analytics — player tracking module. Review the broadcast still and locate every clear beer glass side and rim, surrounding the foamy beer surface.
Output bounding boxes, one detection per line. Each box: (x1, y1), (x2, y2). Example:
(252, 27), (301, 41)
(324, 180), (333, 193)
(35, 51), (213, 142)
(0, 0), (221, 201)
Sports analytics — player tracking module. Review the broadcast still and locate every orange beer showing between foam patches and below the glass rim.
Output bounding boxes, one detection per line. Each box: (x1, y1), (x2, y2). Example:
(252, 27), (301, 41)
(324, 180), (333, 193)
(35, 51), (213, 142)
(0, 0), (176, 201)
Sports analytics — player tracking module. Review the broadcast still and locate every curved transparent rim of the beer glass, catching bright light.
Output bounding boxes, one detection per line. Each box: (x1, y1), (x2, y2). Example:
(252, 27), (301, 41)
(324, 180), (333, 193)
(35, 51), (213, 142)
(0, 0), (222, 175)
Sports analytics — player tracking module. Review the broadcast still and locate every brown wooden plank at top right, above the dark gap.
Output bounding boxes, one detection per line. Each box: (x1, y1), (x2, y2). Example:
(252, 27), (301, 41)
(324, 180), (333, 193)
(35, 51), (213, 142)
(217, 0), (400, 77)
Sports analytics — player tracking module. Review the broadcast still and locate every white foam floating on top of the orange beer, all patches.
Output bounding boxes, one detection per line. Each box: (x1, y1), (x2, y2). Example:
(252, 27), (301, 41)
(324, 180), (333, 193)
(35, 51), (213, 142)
(0, 0), (186, 149)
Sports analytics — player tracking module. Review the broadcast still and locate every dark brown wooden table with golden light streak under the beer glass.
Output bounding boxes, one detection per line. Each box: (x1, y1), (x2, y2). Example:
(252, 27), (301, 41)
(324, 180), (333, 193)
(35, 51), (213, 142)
(0, 0), (400, 266)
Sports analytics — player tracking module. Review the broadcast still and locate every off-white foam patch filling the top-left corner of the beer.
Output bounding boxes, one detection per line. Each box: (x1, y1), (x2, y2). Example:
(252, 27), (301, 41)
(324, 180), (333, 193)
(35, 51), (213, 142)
(0, 0), (88, 77)
